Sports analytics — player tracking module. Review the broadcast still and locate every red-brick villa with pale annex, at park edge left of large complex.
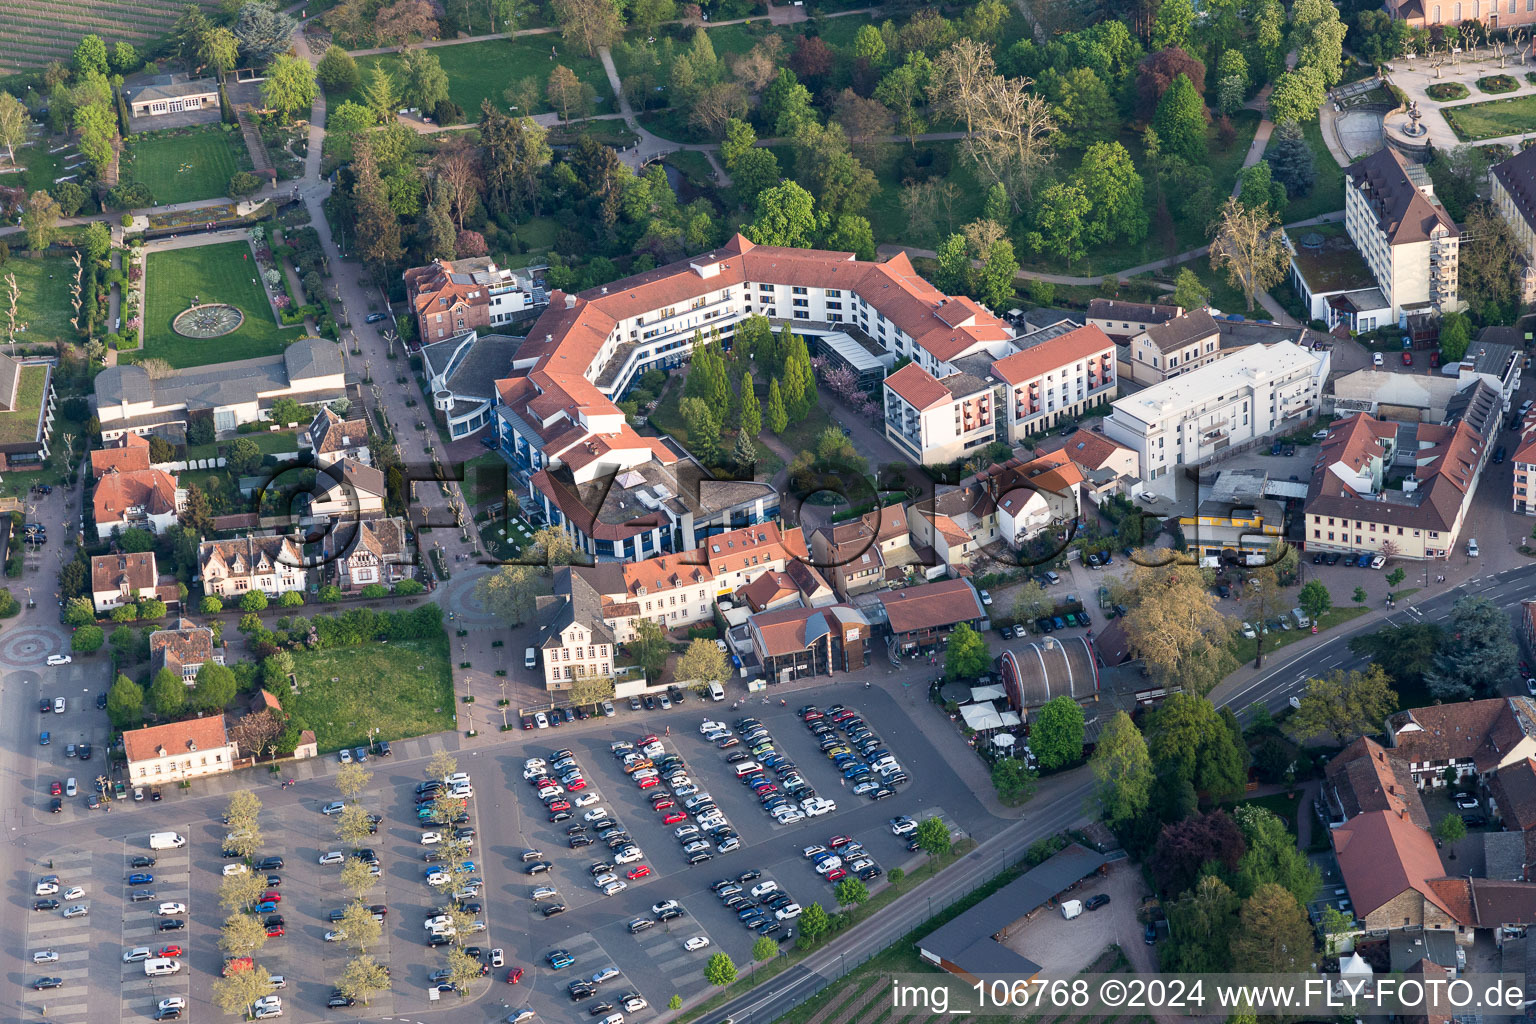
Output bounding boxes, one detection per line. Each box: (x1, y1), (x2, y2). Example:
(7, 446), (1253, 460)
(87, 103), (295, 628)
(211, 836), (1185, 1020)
(404, 256), (544, 345)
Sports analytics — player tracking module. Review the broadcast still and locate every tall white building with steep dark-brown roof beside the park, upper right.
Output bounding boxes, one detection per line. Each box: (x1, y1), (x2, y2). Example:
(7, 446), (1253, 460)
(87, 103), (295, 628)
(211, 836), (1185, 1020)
(1344, 146), (1461, 320)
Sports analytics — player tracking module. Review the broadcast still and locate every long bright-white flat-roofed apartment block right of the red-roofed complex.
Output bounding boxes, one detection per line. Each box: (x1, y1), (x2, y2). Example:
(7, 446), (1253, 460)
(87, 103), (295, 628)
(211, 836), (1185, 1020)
(1104, 341), (1332, 482)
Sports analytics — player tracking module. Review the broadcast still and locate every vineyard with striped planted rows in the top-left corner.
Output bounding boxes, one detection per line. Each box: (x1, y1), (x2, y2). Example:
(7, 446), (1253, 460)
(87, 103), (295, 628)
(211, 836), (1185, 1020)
(0, 0), (217, 75)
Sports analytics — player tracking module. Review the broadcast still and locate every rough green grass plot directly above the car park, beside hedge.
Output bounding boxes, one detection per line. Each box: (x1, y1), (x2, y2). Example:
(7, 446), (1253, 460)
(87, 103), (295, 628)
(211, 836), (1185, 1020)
(281, 636), (455, 754)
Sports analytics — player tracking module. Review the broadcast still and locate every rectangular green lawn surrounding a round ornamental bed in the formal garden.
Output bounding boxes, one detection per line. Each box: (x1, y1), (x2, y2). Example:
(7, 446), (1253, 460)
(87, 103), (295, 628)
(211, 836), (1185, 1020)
(135, 241), (304, 367)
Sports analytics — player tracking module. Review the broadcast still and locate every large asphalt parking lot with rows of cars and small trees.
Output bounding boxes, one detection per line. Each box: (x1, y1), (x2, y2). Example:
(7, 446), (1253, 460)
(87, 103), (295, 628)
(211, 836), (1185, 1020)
(11, 686), (1000, 1024)
